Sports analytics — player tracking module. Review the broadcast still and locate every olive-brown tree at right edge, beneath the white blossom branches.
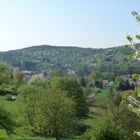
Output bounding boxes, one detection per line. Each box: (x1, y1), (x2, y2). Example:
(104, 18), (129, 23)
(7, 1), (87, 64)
(116, 92), (140, 140)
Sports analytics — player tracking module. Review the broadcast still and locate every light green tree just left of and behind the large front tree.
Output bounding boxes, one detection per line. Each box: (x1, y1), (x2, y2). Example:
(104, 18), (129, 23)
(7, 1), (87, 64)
(17, 84), (45, 132)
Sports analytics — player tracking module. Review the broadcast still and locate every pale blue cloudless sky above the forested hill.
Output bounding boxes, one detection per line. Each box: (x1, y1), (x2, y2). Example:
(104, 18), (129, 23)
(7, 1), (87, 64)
(0, 0), (140, 51)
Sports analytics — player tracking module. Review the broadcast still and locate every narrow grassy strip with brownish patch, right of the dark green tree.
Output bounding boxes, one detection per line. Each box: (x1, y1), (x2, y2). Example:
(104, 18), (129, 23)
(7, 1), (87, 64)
(82, 88), (109, 140)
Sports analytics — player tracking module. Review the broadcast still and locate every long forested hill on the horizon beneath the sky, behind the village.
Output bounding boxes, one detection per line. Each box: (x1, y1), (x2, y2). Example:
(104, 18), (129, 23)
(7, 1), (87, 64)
(0, 45), (140, 75)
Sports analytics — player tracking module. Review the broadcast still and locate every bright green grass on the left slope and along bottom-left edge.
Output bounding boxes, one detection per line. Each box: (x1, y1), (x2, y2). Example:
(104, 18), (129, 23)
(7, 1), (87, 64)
(0, 96), (54, 140)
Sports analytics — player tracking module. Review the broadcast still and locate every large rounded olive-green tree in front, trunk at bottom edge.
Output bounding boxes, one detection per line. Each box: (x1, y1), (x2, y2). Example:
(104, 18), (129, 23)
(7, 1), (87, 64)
(33, 89), (76, 140)
